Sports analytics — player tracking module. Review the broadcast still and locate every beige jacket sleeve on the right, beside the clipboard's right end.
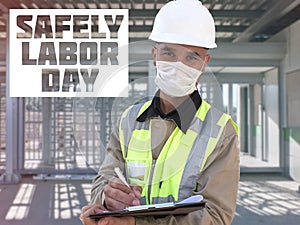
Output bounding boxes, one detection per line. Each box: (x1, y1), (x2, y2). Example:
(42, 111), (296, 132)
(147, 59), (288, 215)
(136, 122), (240, 225)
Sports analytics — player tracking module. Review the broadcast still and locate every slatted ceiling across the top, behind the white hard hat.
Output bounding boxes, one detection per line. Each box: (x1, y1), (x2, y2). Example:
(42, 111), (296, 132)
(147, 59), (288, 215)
(0, 0), (300, 42)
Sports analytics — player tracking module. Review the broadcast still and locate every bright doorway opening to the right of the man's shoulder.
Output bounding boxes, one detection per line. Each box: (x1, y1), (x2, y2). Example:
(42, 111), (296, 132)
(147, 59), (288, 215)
(222, 68), (281, 172)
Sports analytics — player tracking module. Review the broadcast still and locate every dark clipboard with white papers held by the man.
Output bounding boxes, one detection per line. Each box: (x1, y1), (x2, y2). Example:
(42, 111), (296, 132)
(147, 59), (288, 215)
(89, 195), (205, 220)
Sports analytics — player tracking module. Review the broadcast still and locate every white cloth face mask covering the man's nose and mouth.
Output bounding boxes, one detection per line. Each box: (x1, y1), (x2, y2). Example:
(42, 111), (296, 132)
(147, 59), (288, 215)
(155, 61), (202, 97)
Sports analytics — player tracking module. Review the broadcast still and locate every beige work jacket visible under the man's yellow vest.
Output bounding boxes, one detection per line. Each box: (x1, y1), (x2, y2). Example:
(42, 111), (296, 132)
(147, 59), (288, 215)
(91, 117), (240, 225)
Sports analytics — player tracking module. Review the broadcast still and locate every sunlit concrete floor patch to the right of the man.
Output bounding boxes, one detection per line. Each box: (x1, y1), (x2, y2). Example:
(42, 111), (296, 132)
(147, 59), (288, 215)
(232, 175), (300, 225)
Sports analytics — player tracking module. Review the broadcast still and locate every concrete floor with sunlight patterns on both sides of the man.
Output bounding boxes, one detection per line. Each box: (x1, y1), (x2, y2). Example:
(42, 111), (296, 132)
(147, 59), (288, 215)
(0, 175), (300, 225)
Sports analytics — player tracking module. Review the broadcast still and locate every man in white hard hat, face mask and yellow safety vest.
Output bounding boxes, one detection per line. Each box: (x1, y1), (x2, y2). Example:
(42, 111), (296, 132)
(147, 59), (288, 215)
(80, 0), (239, 225)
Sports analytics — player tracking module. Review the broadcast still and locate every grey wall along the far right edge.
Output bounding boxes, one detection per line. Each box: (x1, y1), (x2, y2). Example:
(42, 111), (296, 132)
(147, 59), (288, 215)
(270, 20), (300, 182)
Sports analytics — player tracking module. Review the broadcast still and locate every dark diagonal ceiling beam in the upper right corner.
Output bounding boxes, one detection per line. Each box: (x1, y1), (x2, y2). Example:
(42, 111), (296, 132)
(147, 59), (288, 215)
(233, 0), (300, 43)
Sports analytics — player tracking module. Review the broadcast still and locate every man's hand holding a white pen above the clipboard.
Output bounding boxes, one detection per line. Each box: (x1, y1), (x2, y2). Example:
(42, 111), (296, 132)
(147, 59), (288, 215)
(103, 178), (142, 210)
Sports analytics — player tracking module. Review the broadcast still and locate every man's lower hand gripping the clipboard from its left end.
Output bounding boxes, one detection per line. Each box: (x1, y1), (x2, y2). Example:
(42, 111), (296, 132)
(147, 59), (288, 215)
(80, 205), (135, 225)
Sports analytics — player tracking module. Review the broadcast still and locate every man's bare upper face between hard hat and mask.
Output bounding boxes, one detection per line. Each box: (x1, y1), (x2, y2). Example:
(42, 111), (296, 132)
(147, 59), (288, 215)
(152, 43), (210, 71)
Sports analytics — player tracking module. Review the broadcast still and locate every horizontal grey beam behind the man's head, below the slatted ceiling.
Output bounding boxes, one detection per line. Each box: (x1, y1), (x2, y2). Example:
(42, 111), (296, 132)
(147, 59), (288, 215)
(129, 40), (286, 66)
